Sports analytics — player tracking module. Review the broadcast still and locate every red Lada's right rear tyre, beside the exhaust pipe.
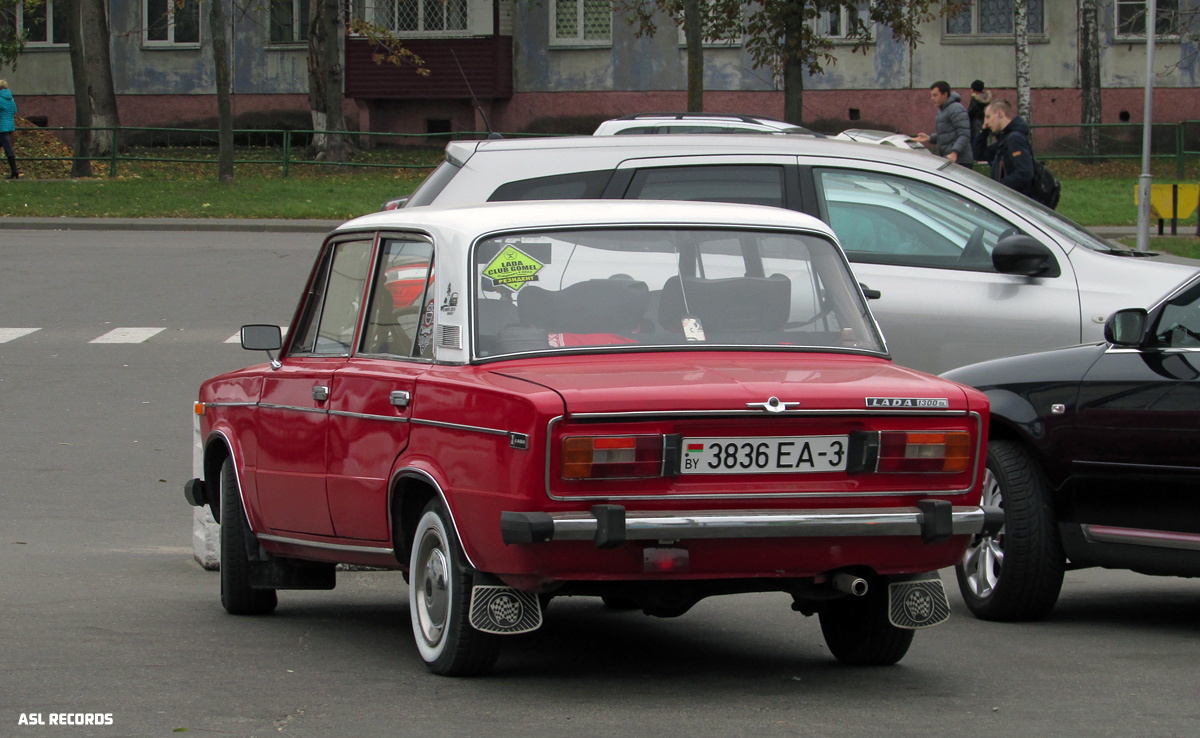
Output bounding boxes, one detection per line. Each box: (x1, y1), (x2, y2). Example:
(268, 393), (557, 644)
(821, 584), (913, 666)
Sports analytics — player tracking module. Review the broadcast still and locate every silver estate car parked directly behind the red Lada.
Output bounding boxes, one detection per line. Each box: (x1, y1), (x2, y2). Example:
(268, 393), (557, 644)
(407, 136), (1198, 372)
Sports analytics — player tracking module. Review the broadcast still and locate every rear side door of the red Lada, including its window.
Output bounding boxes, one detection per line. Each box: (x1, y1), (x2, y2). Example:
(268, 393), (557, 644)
(326, 235), (439, 541)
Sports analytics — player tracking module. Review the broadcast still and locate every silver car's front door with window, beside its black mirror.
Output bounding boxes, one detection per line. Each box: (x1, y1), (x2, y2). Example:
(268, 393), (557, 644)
(812, 166), (1081, 373)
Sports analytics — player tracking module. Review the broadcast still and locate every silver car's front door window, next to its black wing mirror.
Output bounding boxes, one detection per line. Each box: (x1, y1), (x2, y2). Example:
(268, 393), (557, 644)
(815, 169), (1016, 271)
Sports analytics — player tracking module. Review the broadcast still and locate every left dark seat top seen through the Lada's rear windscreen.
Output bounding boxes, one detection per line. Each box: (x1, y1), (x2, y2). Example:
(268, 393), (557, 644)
(517, 278), (650, 334)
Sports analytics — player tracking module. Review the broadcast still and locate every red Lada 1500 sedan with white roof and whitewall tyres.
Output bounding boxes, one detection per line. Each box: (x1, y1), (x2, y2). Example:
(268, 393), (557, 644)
(185, 200), (1002, 674)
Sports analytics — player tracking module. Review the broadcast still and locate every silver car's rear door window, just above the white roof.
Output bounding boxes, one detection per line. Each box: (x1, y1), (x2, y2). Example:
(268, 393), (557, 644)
(625, 164), (784, 208)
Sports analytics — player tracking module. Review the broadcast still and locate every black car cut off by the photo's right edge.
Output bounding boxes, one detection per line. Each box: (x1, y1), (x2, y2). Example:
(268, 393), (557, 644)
(943, 278), (1200, 620)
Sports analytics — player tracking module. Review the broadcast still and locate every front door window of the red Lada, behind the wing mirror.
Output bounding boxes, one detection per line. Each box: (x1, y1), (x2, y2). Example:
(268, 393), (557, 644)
(289, 240), (372, 356)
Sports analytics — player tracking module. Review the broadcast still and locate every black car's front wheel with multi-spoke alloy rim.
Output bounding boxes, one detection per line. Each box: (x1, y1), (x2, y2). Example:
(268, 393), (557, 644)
(955, 440), (1066, 620)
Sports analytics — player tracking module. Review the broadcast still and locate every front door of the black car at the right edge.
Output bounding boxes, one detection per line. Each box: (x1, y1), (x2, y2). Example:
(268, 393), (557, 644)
(1073, 279), (1200, 534)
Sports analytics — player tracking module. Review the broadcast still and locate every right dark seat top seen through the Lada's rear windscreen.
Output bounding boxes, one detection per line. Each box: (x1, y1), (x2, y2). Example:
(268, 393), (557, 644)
(659, 274), (792, 332)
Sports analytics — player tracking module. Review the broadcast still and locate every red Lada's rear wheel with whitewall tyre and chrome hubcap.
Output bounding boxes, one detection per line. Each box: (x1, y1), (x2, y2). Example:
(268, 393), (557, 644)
(408, 500), (500, 677)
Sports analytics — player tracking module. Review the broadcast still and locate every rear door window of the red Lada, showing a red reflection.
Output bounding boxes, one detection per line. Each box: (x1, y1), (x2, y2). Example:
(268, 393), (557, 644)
(360, 239), (433, 356)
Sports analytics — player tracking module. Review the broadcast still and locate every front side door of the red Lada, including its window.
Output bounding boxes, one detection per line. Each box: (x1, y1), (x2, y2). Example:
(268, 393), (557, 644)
(254, 238), (373, 535)
